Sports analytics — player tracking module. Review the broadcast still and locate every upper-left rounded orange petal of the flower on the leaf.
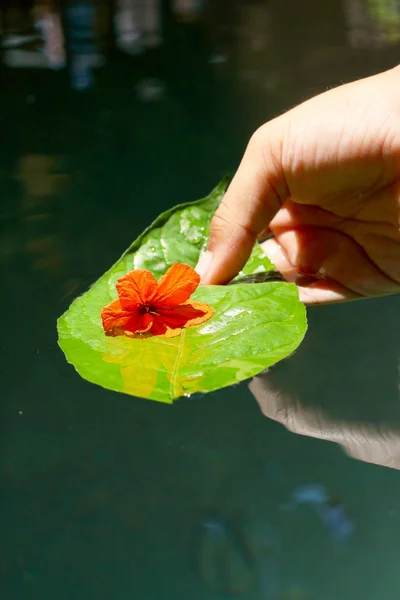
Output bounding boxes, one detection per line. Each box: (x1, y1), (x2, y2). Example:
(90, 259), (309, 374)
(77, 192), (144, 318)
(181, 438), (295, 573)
(116, 269), (157, 310)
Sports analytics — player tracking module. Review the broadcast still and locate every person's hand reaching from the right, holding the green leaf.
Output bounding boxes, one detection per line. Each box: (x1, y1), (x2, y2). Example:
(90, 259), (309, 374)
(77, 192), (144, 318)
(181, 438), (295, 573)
(197, 67), (400, 304)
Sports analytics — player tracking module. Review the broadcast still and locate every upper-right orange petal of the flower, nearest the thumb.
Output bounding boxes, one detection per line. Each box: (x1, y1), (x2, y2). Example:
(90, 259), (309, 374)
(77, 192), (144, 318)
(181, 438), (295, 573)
(152, 263), (200, 309)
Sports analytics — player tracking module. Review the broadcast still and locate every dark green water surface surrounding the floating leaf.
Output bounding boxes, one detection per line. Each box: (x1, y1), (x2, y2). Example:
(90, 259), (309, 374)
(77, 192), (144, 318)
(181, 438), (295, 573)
(0, 0), (400, 600)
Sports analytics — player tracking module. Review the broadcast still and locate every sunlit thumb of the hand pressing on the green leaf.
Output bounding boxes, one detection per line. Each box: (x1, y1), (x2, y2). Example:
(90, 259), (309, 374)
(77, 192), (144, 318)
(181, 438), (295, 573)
(196, 117), (289, 284)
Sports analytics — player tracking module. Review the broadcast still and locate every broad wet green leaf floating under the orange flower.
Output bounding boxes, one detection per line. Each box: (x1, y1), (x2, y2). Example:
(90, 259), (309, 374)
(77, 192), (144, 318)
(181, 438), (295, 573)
(58, 181), (307, 402)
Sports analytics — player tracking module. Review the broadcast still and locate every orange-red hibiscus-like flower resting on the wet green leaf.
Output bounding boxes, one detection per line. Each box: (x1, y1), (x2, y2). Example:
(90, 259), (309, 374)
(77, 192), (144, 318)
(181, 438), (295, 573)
(101, 263), (213, 337)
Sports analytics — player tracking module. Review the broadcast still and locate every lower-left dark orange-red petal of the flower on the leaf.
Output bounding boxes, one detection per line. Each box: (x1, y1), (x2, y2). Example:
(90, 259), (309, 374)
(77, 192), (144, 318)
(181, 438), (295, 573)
(101, 300), (153, 335)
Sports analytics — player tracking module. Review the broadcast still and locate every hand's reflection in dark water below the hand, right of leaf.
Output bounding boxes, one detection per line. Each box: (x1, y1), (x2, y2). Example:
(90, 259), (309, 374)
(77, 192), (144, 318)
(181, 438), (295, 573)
(250, 297), (400, 469)
